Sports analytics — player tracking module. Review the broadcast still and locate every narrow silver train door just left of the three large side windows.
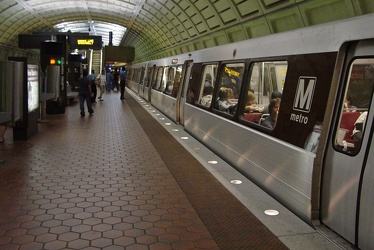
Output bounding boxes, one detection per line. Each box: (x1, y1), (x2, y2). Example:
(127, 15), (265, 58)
(177, 61), (192, 125)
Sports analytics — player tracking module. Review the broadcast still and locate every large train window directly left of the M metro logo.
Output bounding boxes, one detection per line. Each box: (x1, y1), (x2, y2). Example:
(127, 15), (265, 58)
(240, 61), (288, 129)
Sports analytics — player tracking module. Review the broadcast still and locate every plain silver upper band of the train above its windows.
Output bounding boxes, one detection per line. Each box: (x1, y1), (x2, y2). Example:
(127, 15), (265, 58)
(133, 14), (374, 67)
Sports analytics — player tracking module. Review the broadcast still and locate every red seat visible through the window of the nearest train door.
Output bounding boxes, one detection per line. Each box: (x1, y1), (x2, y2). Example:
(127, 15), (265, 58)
(336, 112), (361, 150)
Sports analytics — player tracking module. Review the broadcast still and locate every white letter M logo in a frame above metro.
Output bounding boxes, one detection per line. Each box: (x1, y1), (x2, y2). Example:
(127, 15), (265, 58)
(293, 76), (317, 113)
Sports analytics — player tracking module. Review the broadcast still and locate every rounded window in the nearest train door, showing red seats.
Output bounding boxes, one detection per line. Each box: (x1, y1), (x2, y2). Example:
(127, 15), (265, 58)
(335, 59), (374, 155)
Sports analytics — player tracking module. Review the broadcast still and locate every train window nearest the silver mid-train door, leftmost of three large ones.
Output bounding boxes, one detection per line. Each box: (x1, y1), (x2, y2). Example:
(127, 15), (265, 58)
(196, 63), (218, 108)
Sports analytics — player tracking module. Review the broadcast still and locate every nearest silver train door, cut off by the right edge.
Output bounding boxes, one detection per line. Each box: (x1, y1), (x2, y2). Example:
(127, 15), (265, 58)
(321, 40), (374, 249)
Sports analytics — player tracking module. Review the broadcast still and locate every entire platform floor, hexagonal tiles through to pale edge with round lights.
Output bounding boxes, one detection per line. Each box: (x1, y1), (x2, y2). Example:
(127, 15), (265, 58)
(0, 89), (356, 250)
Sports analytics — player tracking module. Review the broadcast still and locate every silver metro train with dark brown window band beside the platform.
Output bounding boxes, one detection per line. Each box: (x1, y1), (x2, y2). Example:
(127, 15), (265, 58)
(127, 14), (374, 249)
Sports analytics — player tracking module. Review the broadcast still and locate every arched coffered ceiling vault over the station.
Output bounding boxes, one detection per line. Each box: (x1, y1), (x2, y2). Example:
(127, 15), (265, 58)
(0, 0), (374, 60)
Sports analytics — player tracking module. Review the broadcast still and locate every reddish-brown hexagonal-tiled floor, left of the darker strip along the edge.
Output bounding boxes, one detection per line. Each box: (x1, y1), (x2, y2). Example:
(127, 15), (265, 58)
(0, 92), (286, 250)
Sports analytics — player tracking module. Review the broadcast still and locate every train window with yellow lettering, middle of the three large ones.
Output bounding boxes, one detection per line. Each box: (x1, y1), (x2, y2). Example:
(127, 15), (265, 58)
(214, 63), (244, 115)
